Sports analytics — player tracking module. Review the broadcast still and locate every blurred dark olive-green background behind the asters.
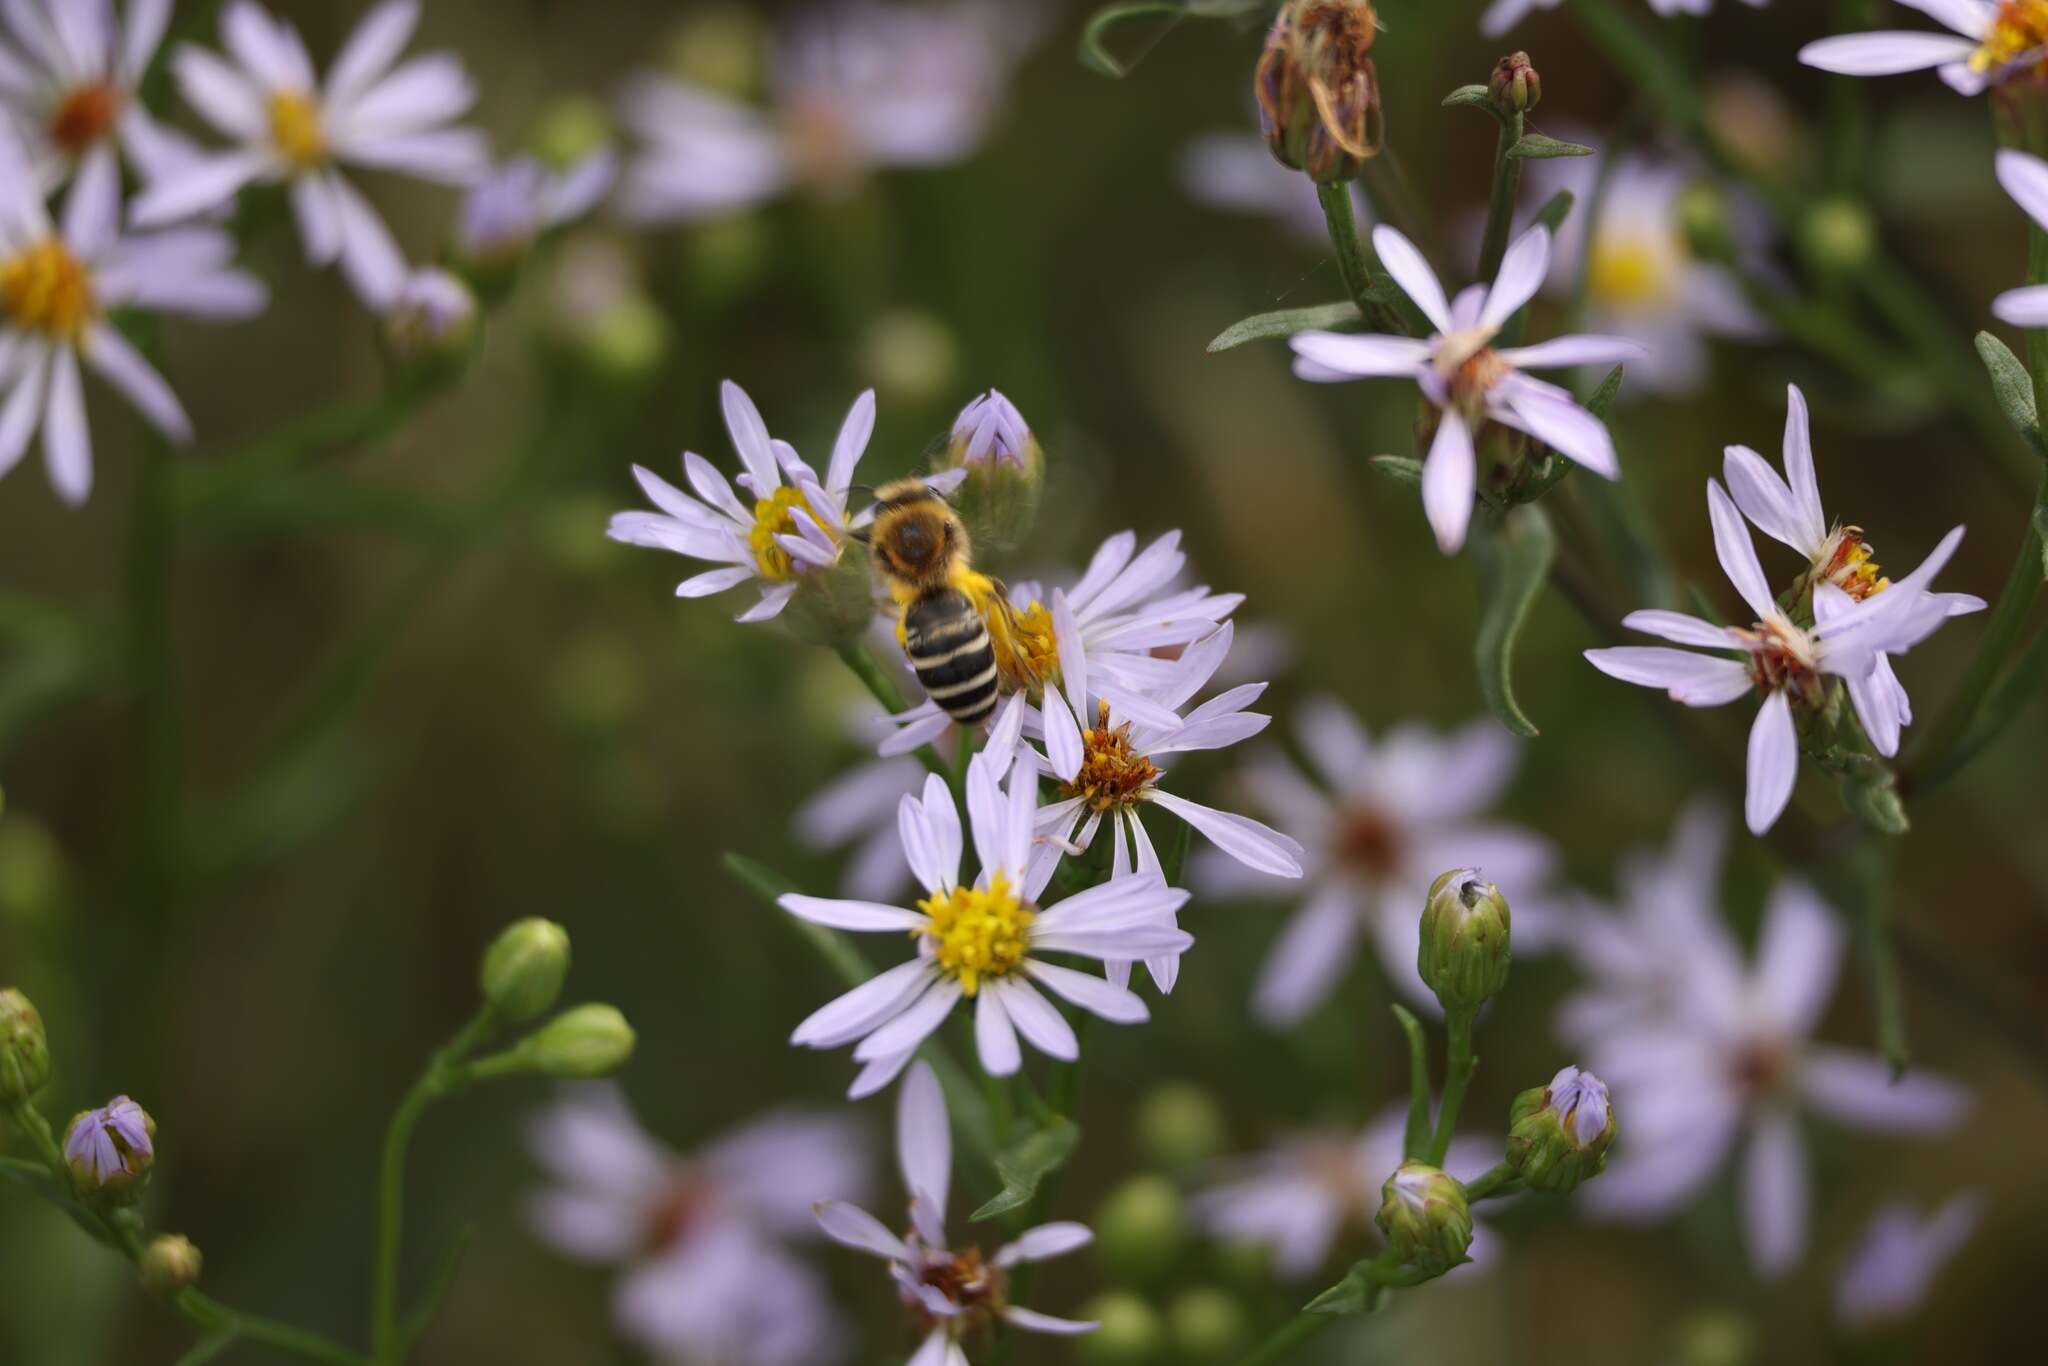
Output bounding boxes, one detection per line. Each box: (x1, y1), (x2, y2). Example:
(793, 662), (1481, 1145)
(0, 0), (2048, 1366)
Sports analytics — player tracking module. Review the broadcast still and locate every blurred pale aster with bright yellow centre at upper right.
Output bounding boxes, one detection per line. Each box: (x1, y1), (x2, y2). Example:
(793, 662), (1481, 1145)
(1524, 146), (1769, 397)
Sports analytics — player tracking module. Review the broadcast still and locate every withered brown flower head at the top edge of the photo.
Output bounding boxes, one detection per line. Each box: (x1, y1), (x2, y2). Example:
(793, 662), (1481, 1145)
(1251, 0), (1386, 184)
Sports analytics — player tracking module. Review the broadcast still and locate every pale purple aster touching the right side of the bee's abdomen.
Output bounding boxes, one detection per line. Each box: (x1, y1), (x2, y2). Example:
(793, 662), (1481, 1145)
(881, 528), (1245, 754)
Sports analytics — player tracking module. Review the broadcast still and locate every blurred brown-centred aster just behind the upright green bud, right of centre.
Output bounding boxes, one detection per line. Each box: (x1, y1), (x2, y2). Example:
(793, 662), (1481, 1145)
(1196, 698), (1556, 1028)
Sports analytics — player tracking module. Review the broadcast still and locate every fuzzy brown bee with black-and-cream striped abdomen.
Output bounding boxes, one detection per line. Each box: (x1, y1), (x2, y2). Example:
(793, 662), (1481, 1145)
(868, 479), (1024, 725)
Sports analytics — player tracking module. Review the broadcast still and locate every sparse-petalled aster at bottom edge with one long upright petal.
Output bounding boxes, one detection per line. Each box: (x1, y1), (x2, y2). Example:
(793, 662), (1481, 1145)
(815, 1063), (1098, 1366)
